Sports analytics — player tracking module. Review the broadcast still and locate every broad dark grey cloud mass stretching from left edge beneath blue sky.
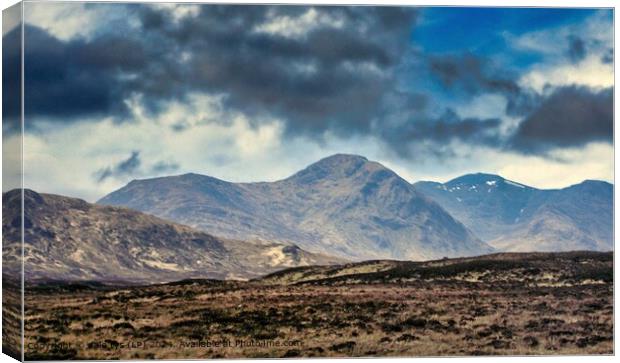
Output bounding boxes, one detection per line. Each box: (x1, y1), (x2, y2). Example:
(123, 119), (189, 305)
(14, 4), (612, 162)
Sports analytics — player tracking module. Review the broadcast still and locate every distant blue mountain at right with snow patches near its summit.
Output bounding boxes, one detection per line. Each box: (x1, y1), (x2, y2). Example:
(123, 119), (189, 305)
(414, 174), (613, 252)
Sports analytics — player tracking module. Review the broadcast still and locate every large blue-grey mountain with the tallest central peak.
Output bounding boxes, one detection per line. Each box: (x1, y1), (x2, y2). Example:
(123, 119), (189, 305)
(98, 154), (493, 260)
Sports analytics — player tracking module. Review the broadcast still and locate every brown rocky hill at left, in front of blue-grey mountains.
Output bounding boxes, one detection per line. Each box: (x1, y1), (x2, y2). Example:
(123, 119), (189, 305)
(2, 190), (342, 283)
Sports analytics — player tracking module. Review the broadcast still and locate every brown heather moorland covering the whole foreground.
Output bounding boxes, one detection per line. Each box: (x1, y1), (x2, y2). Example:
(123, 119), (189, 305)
(3, 253), (613, 360)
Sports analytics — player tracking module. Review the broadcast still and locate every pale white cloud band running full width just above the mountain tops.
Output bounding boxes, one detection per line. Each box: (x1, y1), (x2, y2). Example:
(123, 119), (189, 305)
(12, 87), (613, 201)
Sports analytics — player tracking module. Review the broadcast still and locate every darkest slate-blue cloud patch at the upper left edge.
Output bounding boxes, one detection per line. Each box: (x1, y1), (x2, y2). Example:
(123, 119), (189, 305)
(3, 25), (147, 122)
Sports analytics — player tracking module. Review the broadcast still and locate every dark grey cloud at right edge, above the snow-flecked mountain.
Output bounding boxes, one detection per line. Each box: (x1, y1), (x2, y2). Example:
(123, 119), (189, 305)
(510, 86), (613, 153)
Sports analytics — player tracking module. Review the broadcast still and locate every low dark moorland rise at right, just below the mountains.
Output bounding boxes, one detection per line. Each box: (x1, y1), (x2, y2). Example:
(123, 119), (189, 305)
(256, 251), (613, 286)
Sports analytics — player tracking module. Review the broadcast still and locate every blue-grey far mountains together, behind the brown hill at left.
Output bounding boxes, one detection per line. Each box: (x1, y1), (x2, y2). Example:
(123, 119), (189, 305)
(98, 154), (613, 260)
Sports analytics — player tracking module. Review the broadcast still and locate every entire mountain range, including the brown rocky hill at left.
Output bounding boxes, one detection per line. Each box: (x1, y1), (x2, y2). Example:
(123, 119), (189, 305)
(2, 154), (613, 283)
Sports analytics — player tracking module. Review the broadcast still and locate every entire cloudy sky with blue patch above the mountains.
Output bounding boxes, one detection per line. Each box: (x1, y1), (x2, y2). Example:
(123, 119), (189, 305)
(3, 2), (614, 201)
